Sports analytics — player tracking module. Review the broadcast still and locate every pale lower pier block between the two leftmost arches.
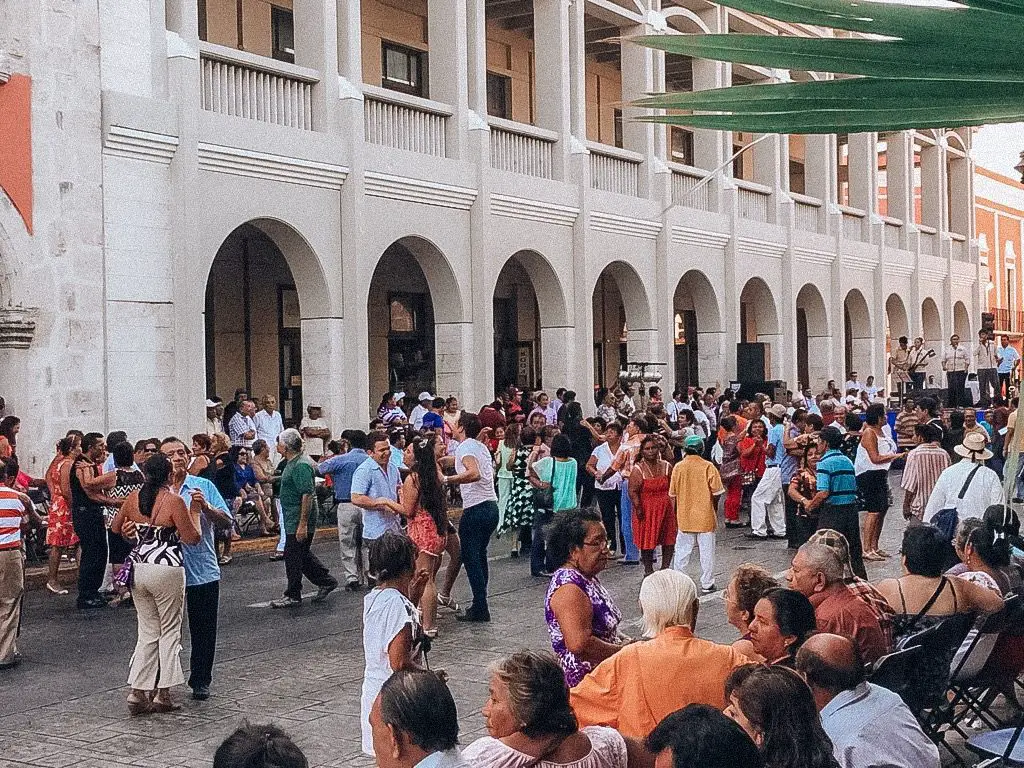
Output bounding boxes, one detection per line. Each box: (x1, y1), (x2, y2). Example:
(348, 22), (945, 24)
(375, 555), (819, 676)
(301, 317), (350, 434)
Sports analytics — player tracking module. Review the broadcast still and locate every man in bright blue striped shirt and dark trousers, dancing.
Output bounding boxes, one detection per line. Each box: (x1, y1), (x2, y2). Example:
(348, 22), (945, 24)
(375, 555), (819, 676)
(807, 427), (867, 579)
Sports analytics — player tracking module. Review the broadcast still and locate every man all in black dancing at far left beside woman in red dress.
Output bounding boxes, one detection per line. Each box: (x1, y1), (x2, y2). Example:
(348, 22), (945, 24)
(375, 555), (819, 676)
(70, 432), (116, 609)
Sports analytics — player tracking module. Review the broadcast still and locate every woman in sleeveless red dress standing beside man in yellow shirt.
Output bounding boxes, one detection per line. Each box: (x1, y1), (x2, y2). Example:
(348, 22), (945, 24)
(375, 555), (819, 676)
(629, 435), (677, 575)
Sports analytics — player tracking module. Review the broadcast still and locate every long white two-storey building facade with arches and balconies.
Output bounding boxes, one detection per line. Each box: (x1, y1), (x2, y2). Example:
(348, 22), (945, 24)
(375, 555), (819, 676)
(0, 0), (983, 470)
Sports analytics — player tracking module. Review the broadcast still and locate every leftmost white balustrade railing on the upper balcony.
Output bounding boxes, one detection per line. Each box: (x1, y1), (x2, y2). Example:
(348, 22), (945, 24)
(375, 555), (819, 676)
(200, 43), (319, 131)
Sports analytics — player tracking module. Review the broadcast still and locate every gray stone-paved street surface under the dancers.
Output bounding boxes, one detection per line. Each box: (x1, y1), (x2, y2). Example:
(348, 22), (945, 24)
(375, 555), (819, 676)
(0, 487), (937, 768)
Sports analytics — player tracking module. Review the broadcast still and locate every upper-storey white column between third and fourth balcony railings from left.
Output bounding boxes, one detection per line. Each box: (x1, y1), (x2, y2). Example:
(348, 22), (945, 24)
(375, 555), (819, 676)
(534, 0), (587, 180)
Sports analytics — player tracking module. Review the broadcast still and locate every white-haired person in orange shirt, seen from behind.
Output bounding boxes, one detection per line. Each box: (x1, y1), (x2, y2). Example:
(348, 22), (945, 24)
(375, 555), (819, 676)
(569, 570), (751, 738)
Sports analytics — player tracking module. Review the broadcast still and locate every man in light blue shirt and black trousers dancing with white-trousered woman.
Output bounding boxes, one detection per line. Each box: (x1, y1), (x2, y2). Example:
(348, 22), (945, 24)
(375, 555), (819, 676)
(160, 437), (231, 701)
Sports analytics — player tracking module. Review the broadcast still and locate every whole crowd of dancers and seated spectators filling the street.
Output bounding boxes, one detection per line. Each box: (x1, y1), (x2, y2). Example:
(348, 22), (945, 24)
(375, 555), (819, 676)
(6, 374), (1024, 768)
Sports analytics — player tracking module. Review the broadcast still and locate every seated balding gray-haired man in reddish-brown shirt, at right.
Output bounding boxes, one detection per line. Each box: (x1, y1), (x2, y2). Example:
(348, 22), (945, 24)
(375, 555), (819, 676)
(786, 542), (890, 664)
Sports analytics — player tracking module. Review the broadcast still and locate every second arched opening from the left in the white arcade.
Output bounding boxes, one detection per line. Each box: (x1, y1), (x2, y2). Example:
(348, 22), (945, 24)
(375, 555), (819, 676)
(367, 237), (466, 411)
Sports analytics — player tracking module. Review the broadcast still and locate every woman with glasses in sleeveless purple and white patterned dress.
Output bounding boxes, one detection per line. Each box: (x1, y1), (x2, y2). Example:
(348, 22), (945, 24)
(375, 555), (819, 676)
(544, 509), (630, 688)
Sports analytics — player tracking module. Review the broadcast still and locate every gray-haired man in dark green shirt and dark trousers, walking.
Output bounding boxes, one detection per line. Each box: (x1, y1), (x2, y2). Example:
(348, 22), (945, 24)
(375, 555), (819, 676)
(270, 429), (338, 608)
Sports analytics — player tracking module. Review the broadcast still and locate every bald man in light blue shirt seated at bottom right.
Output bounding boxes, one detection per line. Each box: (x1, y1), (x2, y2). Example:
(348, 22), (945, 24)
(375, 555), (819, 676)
(796, 633), (940, 768)
